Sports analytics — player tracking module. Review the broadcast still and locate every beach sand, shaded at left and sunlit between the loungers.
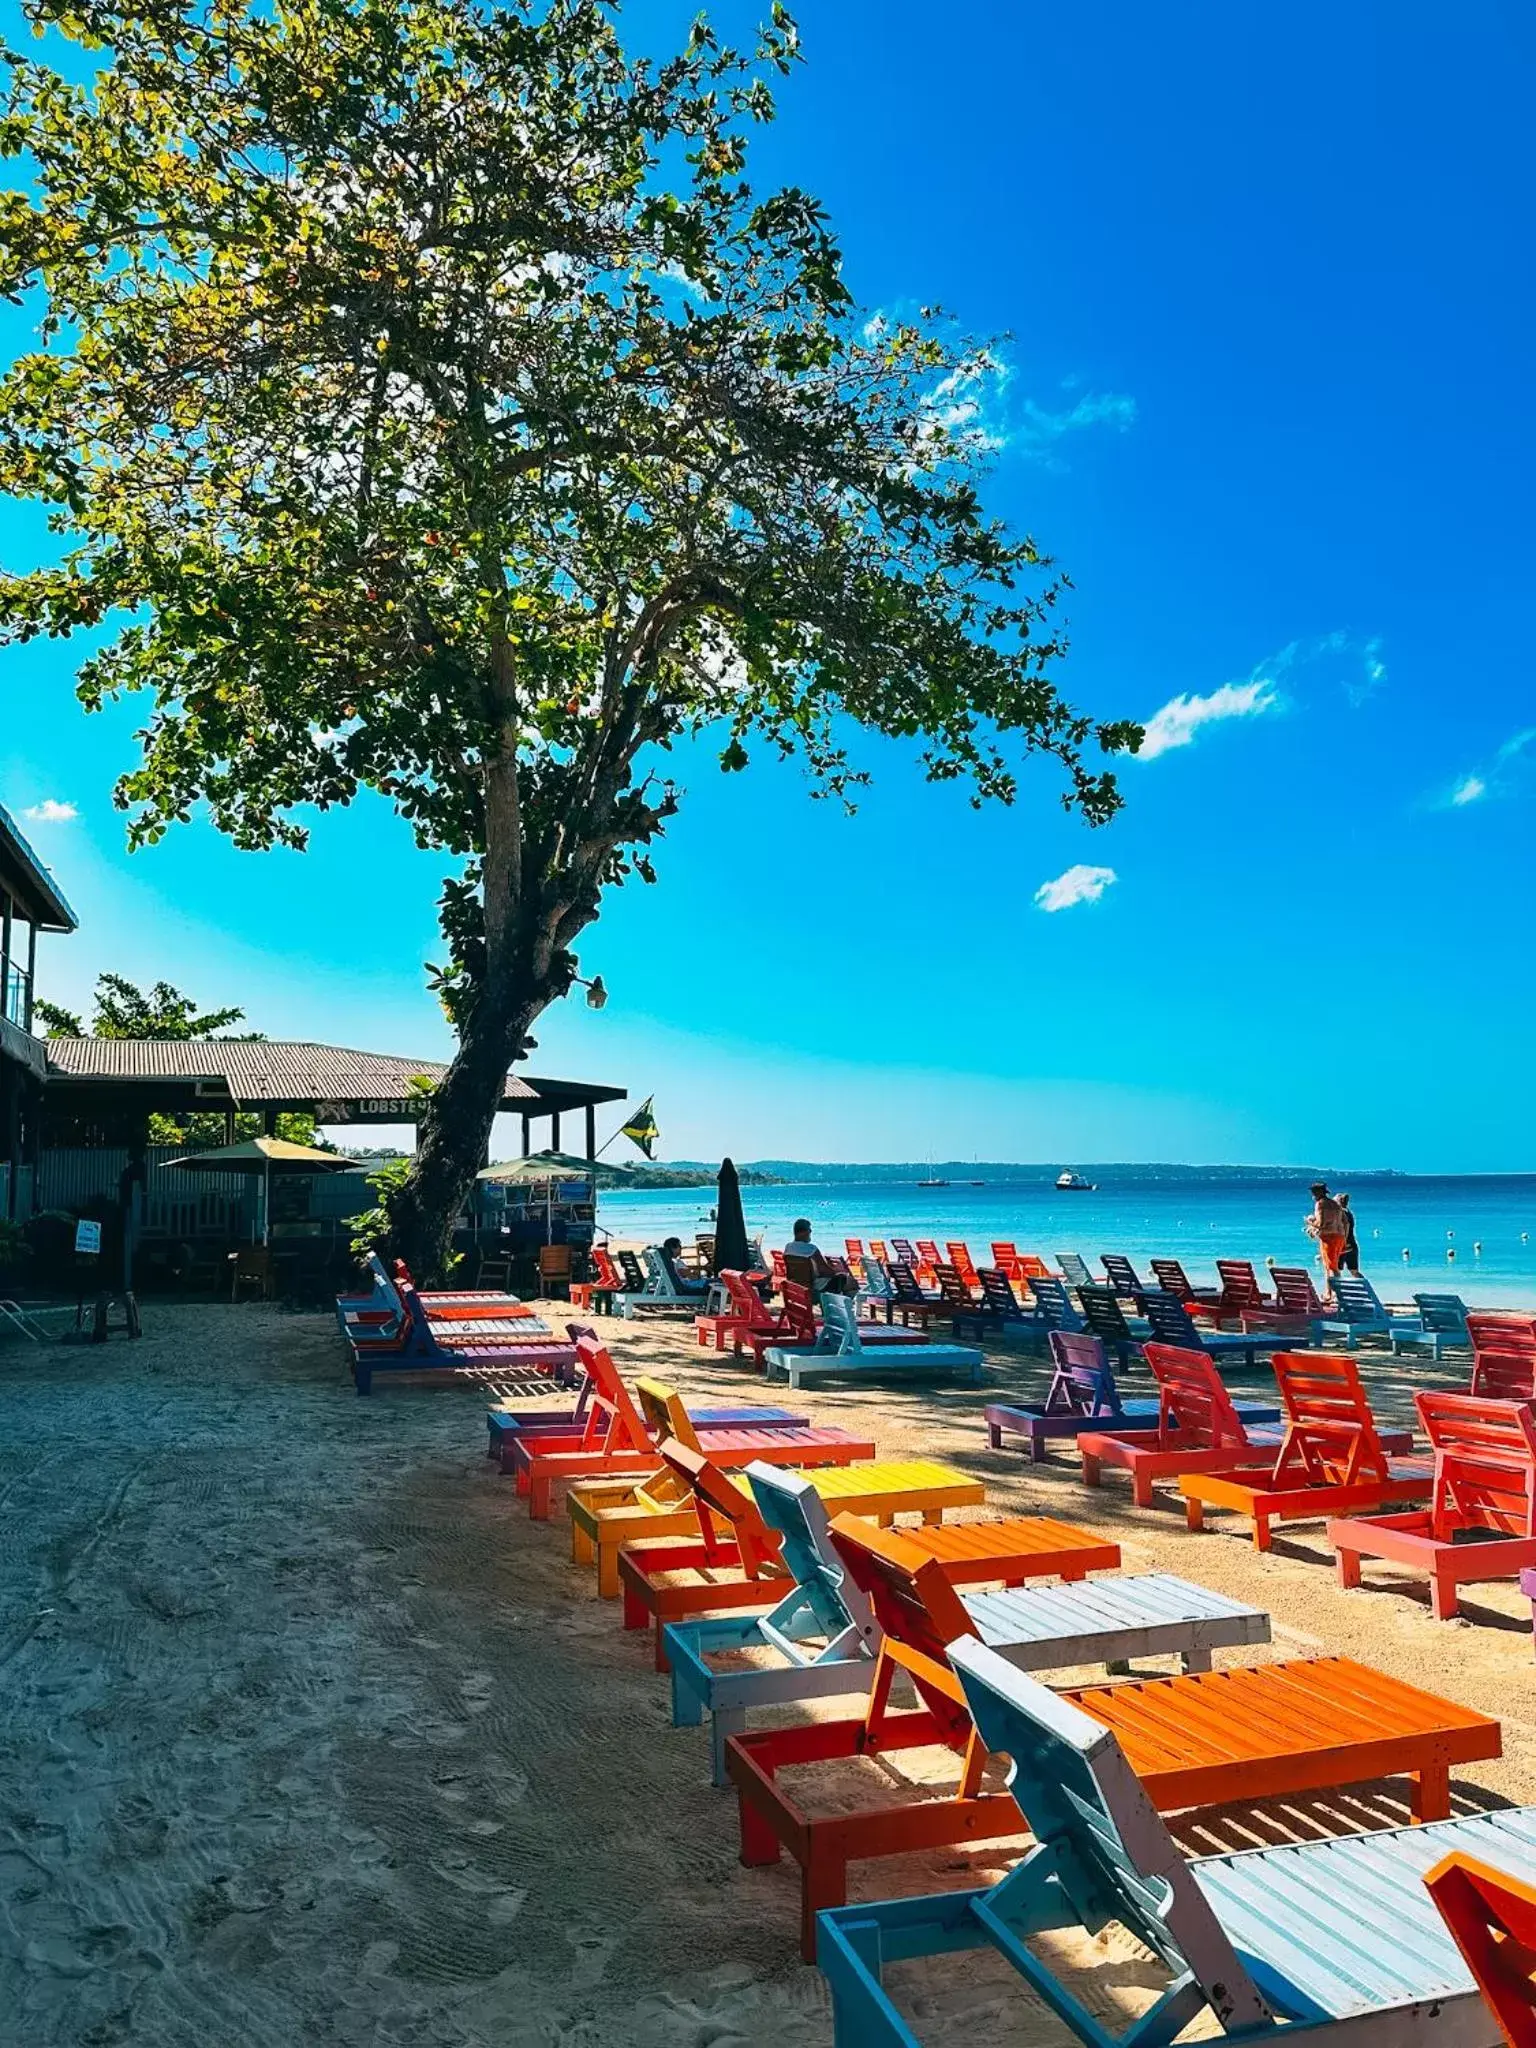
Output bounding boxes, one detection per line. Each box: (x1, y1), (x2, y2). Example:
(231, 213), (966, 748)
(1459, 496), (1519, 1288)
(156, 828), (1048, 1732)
(0, 1305), (1536, 2048)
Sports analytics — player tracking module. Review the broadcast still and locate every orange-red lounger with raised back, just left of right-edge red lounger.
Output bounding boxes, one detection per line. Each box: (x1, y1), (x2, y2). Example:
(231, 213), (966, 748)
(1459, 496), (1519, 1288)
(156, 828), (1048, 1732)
(1178, 1352), (1434, 1550)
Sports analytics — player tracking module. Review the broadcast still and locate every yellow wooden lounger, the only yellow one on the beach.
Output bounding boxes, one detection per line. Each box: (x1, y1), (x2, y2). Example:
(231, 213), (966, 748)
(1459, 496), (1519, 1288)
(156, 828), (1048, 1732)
(565, 1415), (987, 1599)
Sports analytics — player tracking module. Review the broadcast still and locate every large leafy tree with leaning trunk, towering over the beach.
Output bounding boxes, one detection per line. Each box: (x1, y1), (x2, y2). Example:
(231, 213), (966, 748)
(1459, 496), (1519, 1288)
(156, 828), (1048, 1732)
(0, 0), (1137, 1268)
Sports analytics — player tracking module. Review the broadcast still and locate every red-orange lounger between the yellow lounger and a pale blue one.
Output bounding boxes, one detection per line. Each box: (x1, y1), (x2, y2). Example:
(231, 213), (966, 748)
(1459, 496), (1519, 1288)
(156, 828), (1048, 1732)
(618, 1440), (1120, 1671)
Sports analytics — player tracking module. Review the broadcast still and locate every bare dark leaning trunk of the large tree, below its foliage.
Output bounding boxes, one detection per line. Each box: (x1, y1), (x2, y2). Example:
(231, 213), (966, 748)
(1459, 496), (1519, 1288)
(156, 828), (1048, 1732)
(389, 981), (553, 1284)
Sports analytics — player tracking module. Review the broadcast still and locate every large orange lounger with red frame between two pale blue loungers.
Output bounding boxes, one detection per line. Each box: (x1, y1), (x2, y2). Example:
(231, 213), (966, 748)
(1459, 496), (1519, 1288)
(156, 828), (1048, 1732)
(725, 1516), (1501, 1949)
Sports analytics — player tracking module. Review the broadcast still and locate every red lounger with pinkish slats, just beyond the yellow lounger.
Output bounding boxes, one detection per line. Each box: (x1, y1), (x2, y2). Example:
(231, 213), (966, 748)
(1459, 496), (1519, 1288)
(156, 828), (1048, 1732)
(502, 1331), (874, 1522)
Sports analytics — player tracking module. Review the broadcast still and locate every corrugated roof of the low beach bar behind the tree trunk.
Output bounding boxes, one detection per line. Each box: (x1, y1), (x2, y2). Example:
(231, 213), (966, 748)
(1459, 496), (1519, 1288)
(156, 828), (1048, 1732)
(47, 1038), (625, 1108)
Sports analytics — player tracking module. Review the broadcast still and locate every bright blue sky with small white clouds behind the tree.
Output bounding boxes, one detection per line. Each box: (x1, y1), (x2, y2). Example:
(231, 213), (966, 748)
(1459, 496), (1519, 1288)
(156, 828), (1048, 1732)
(0, 0), (1536, 1171)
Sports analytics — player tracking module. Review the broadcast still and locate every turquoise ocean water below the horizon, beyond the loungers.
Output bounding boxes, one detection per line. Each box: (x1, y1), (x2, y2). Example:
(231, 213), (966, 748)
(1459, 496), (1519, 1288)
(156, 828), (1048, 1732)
(598, 1169), (1536, 1309)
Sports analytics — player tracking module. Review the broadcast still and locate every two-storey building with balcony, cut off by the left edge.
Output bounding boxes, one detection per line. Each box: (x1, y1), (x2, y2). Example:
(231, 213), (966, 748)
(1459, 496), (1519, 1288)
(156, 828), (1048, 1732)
(0, 805), (78, 1223)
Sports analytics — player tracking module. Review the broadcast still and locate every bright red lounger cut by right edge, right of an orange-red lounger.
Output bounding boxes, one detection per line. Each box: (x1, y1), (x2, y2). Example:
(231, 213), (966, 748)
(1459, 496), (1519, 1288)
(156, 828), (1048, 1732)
(1327, 1393), (1536, 1622)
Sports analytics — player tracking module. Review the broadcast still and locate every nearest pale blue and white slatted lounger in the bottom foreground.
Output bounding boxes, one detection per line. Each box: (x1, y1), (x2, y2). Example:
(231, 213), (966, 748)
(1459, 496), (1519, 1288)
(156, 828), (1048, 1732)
(819, 1640), (1536, 2048)
